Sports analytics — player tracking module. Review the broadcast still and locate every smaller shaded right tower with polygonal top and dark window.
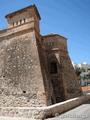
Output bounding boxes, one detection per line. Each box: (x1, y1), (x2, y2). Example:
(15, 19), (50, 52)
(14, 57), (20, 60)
(43, 33), (82, 103)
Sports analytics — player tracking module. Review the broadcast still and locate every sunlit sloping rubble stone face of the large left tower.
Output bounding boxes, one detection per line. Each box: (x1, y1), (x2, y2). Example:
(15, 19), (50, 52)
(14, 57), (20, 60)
(0, 30), (46, 107)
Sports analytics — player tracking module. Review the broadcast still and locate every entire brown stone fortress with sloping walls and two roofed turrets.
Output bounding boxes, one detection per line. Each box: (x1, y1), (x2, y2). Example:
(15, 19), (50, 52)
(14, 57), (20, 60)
(0, 5), (82, 107)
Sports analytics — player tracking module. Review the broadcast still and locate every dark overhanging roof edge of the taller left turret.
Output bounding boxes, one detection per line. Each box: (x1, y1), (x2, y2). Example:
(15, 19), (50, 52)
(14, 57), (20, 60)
(5, 4), (41, 20)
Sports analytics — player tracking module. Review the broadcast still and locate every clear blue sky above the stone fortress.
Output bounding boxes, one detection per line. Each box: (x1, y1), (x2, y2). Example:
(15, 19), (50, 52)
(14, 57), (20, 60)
(0, 0), (90, 64)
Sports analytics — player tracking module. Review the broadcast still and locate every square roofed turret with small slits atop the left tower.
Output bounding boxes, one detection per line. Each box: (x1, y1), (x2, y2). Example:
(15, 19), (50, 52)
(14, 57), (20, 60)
(5, 5), (41, 31)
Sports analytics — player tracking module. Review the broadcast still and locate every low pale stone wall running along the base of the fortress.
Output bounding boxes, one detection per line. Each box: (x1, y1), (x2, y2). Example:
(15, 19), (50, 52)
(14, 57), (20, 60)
(0, 93), (90, 119)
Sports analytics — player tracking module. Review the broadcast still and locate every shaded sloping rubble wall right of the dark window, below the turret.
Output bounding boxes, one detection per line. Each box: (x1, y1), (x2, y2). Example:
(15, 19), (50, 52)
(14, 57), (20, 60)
(60, 52), (82, 100)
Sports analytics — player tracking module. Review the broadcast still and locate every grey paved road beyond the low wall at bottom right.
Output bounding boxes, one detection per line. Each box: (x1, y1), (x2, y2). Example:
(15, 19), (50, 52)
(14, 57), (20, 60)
(46, 101), (90, 120)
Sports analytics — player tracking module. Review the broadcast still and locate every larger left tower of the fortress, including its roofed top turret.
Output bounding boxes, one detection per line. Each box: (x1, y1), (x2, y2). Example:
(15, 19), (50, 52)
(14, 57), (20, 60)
(0, 5), (53, 107)
